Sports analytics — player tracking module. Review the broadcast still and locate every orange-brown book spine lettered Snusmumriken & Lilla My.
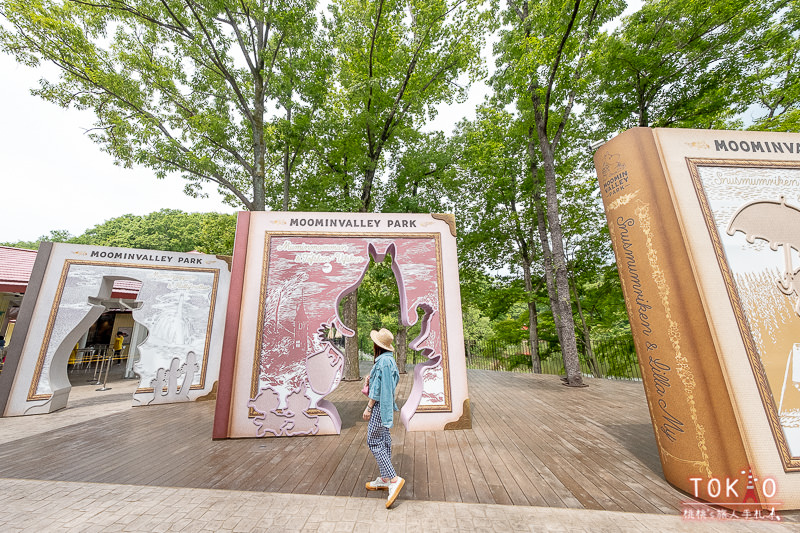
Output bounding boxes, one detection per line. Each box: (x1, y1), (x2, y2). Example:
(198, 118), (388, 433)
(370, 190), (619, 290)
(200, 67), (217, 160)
(595, 128), (748, 505)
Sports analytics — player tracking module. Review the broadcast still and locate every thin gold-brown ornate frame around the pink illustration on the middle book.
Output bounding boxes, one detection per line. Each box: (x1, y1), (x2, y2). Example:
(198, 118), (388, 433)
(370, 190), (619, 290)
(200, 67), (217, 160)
(248, 231), (453, 418)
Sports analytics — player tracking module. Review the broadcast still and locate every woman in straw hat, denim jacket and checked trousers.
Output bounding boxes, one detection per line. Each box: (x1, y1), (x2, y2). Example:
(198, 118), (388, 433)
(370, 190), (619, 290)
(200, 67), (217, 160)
(362, 328), (406, 509)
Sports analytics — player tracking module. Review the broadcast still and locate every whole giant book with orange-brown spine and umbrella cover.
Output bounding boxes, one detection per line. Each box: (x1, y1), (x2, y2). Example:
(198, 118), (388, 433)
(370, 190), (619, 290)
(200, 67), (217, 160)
(595, 128), (800, 511)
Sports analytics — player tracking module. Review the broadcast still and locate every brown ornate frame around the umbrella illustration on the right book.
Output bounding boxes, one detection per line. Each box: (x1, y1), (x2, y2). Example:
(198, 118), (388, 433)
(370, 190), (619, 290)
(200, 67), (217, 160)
(685, 157), (800, 472)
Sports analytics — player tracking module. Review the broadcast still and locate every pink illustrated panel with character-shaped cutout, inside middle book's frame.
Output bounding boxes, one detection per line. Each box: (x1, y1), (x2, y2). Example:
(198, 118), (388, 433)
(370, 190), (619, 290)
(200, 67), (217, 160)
(250, 233), (449, 435)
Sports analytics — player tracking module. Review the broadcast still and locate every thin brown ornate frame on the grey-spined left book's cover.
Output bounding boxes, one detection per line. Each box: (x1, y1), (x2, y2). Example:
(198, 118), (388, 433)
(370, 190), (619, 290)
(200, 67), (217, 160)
(27, 259), (219, 401)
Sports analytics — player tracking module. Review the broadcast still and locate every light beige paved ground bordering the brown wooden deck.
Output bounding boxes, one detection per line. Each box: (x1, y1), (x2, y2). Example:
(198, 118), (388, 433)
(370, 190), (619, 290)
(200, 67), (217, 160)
(0, 372), (797, 533)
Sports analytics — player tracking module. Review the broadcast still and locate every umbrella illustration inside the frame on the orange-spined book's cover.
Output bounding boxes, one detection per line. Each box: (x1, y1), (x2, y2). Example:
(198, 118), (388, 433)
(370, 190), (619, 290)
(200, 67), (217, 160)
(693, 161), (800, 464)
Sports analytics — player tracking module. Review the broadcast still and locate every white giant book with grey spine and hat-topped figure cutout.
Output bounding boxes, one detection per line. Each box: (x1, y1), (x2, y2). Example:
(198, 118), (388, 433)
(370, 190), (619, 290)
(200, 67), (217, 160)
(0, 242), (230, 416)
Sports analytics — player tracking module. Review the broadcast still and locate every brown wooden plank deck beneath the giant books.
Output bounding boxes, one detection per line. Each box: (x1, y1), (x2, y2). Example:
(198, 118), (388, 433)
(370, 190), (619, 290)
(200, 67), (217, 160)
(0, 370), (687, 514)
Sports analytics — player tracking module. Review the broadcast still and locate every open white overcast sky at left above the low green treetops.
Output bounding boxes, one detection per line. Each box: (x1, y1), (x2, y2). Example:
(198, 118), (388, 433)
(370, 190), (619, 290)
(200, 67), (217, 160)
(0, 53), (241, 242)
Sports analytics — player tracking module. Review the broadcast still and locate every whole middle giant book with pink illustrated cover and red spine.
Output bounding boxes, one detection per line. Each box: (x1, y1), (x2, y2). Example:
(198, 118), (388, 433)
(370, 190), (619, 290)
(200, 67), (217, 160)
(214, 212), (470, 438)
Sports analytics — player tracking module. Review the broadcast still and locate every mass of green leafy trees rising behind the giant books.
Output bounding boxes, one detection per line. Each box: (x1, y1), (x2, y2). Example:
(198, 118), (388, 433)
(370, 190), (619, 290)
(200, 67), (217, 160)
(0, 0), (800, 384)
